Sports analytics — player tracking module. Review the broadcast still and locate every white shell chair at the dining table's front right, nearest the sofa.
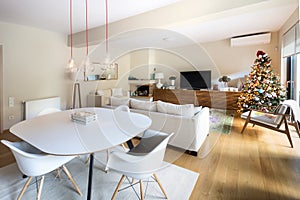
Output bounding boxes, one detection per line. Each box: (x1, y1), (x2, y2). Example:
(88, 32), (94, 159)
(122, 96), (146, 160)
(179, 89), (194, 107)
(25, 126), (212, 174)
(107, 130), (173, 199)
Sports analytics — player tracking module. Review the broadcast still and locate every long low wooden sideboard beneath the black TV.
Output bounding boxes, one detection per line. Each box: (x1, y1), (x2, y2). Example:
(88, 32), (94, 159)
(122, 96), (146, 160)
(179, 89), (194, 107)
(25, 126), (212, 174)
(153, 89), (241, 110)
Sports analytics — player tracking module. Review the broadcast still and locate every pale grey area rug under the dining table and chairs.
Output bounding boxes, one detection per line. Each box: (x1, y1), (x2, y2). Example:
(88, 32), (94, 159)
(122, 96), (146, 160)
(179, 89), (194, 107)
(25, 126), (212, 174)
(0, 153), (199, 200)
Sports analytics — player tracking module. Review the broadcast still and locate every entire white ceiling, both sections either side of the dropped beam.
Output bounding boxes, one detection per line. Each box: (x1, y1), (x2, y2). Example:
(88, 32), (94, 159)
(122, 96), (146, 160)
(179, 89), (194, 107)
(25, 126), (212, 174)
(0, 0), (298, 42)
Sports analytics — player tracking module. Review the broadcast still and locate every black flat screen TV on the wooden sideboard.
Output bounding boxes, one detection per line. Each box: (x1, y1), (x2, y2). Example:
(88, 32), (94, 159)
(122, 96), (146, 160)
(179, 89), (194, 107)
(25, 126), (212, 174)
(180, 70), (211, 90)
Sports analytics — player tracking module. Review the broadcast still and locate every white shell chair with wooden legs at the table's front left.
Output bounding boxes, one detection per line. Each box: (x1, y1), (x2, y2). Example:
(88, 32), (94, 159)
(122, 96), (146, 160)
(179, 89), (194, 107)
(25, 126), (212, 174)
(1, 140), (82, 200)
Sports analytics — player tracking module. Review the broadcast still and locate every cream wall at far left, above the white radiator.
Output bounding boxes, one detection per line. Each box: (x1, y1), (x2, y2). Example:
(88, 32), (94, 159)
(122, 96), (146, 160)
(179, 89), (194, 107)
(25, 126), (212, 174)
(0, 22), (71, 130)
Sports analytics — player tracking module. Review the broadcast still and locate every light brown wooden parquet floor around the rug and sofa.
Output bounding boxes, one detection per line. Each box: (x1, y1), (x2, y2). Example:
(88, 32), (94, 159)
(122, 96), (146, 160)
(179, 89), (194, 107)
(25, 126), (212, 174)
(0, 117), (300, 200)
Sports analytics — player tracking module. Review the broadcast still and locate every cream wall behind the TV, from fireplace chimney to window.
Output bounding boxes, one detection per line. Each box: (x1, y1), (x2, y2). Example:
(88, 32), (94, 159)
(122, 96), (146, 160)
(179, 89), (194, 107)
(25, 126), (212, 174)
(120, 39), (280, 87)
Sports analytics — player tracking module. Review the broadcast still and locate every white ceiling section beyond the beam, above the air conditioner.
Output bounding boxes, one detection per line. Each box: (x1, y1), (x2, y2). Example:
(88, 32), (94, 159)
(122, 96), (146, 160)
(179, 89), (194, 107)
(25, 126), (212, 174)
(173, 0), (298, 42)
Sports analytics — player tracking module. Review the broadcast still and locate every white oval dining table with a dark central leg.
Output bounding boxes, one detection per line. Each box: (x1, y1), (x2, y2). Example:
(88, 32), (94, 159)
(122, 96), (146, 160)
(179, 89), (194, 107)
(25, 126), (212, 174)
(10, 107), (152, 199)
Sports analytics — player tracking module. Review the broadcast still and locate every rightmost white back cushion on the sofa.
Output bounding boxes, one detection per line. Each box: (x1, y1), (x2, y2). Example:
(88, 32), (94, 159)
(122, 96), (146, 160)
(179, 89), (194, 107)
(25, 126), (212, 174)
(157, 101), (195, 117)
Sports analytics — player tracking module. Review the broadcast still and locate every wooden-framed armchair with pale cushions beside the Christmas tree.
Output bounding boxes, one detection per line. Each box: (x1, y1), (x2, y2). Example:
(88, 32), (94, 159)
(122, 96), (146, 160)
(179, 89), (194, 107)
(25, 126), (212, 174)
(241, 104), (293, 148)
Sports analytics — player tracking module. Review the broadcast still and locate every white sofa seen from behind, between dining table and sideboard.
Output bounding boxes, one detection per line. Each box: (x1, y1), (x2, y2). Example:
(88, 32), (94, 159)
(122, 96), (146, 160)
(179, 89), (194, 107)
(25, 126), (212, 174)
(109, 97), (209, 155)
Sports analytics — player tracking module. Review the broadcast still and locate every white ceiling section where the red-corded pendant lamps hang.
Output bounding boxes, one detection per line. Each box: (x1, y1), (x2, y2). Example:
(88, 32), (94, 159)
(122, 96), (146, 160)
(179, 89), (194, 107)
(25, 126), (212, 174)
(0, 0), (180, 34)
